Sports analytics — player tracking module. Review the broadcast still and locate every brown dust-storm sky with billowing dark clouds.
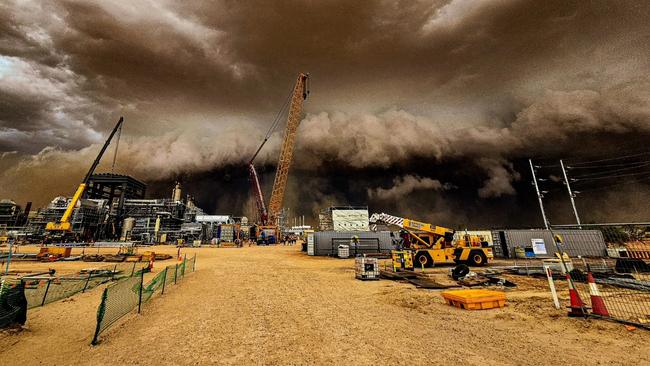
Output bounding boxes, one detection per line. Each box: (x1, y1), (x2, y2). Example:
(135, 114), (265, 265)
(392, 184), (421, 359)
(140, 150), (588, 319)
(0, 0), (650, 223)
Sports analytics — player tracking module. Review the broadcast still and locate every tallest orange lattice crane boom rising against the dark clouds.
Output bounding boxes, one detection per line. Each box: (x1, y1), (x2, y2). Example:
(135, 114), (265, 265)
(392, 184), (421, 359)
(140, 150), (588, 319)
(269, 73), (309, 224)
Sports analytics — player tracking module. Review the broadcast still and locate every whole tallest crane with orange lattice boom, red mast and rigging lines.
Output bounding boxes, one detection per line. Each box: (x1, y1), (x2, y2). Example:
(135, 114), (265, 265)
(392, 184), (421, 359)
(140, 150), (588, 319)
(248, 73), (309, 244)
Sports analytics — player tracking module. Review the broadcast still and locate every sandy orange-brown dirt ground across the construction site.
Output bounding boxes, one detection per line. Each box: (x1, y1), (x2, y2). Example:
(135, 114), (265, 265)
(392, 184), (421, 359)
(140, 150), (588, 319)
(0, 246), (650, 365)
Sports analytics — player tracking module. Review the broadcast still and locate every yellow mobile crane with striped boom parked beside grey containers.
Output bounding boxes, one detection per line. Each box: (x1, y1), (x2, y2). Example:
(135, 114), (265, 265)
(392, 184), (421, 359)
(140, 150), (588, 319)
(369, 213), (494, 267)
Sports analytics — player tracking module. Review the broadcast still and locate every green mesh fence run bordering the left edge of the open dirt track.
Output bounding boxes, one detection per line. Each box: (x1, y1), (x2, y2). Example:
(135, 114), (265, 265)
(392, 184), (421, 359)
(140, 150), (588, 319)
(92, 255), (196, 344)
